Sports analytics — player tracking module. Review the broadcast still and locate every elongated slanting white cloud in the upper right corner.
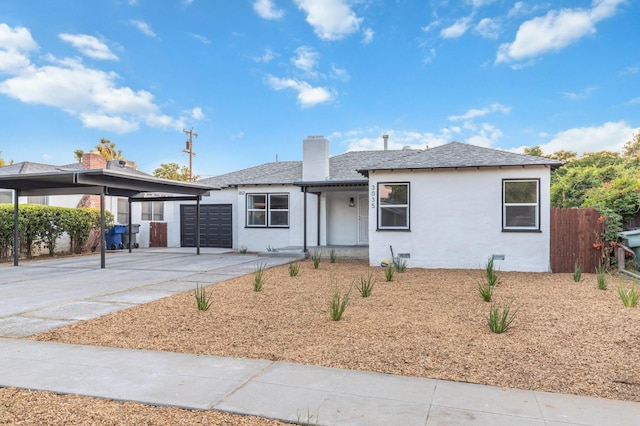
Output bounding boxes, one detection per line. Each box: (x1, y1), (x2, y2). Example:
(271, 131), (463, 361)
(496, 0), (625, 63)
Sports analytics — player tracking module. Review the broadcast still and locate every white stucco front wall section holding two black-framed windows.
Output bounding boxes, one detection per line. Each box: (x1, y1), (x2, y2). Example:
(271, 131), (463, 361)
(369, 166), (550, 272)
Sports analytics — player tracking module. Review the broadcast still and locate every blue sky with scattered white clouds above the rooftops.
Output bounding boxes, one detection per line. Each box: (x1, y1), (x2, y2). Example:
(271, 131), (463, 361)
(0, 0), (640, 177)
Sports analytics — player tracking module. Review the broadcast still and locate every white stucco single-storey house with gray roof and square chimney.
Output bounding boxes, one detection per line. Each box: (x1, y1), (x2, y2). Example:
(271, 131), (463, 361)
(170, 136), (562, 271)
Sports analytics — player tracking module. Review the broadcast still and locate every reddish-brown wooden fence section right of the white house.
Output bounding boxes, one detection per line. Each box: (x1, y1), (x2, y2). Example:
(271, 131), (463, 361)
(551, 209), (604, 273)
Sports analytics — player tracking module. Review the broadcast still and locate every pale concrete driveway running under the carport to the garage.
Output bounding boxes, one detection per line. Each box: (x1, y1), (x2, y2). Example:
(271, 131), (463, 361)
(0, 248), (302, 337)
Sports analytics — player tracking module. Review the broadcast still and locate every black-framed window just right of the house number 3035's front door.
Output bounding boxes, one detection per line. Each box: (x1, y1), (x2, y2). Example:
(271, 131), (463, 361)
(378, 183), (409, 229)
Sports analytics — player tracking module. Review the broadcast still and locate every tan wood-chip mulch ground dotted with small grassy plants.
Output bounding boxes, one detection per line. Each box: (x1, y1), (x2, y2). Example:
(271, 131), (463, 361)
(0, 260), (640, 425)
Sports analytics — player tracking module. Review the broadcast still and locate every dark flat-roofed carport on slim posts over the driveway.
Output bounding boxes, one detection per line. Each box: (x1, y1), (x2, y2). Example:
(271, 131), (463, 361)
(0, 169), (219, 268)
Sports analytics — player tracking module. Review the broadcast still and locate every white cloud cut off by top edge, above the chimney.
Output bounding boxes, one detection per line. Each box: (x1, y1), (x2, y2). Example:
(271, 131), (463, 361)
(294, 0), (362, 40)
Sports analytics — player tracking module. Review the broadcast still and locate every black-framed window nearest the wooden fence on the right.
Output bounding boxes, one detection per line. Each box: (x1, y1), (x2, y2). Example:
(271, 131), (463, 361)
(502, 179), (540, 231)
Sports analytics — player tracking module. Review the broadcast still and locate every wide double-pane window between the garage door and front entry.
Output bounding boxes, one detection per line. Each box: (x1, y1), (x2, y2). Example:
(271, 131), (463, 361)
(247, 194), (289, 228)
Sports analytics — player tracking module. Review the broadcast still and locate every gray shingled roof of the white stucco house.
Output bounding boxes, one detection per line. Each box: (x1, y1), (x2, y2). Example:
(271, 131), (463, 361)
(199, 142), (563, 187)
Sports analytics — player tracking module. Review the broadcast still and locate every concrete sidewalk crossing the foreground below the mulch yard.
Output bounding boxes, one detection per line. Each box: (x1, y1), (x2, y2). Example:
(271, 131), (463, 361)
(0, 338), (640, 426)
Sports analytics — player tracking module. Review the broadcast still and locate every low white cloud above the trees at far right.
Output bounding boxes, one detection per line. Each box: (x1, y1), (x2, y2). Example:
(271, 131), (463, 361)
(528, 121), (640, 155)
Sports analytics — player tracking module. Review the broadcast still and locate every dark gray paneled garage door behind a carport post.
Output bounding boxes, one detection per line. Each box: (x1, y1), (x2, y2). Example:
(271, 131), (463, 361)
(180, 204), (233, 248)
